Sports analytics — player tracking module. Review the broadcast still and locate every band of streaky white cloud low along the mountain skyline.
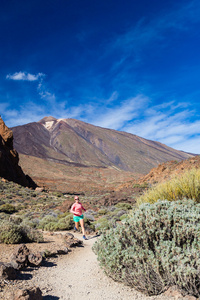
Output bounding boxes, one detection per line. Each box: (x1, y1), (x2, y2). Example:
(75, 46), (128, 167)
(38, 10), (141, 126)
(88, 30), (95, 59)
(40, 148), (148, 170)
(0, 86), (200, 153)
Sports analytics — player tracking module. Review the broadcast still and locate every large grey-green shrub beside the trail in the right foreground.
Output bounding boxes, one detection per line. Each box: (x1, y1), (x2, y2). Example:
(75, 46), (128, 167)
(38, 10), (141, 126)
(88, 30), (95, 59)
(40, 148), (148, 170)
(93, 200), (200, 297)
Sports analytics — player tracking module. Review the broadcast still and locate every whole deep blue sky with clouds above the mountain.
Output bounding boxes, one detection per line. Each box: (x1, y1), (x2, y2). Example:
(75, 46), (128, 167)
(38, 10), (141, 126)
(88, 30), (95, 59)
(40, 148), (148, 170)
(0, 0), (200, 154)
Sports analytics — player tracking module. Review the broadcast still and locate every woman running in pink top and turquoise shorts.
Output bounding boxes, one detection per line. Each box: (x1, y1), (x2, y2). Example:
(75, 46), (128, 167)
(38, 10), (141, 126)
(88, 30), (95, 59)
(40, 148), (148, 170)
(70, 196), (87, 240)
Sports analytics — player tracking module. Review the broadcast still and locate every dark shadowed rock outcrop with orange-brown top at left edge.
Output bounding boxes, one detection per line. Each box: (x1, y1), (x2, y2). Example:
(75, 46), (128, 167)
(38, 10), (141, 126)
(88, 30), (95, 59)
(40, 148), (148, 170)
(0, 117), (34, 186)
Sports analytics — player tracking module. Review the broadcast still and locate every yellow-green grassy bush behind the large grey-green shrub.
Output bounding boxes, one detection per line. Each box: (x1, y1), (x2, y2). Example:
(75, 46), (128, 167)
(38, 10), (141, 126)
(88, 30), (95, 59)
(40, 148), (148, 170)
(137, 169), (200, 204)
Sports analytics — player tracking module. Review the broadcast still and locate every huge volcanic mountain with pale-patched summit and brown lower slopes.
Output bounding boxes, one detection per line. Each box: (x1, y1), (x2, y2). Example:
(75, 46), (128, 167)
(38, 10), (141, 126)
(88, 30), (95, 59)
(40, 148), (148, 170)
(12, 117), (194, 192)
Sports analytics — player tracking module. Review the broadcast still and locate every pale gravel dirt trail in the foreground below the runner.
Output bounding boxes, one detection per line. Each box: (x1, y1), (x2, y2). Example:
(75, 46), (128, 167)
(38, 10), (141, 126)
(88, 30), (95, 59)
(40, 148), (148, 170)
(28, 235), (174, 300)
